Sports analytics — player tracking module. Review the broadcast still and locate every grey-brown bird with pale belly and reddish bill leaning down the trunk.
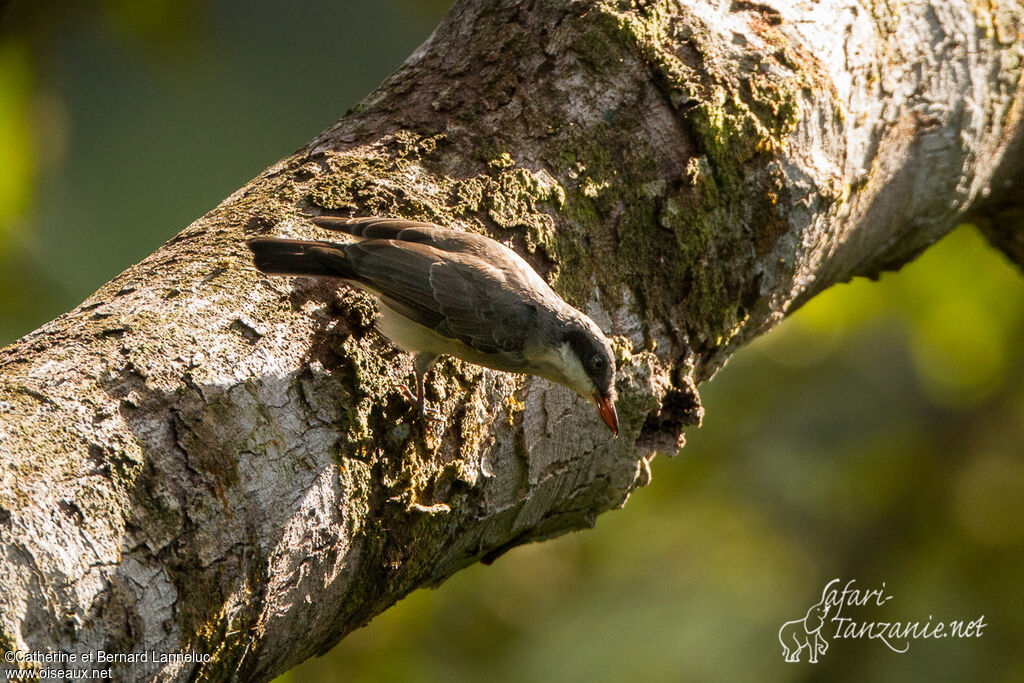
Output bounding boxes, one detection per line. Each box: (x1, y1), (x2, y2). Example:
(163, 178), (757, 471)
(246, 216), (618, 436)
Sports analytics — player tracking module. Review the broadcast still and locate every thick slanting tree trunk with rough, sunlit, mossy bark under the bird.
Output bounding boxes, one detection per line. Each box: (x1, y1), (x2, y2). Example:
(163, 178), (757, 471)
(0, 0), (1024, 680)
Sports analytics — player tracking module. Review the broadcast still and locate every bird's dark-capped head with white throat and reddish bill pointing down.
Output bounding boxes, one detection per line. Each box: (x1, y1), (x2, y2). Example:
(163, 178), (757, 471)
(562, 315), (618, 436)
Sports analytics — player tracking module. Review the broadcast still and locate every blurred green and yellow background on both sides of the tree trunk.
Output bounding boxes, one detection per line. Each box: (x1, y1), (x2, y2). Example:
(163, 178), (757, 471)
(0, 0), (1024, 683)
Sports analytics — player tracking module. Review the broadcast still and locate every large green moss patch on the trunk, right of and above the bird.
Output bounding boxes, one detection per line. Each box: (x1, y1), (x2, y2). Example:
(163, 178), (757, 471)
(540, 1), (815, 349)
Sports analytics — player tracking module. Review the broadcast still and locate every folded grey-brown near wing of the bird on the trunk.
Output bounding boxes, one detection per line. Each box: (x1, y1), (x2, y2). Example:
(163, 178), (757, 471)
(345, 240), (538, 353)
